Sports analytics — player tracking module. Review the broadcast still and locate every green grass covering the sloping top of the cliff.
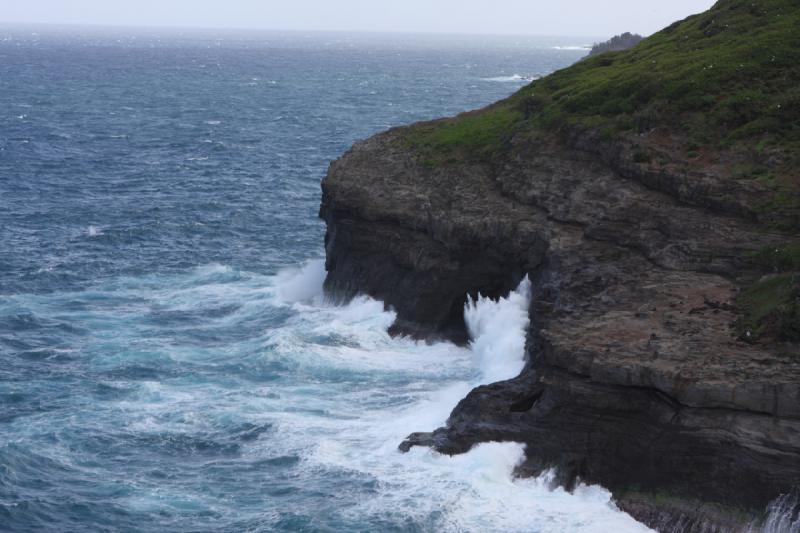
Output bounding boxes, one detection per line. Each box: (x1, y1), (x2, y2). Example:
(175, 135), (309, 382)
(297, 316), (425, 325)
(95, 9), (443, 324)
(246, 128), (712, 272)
(406, 0), (800, 168)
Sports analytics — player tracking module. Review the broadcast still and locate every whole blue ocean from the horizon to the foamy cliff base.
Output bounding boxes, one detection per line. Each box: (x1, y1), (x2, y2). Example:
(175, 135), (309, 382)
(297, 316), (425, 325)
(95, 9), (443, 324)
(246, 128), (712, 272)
(0, 27), (656, 532)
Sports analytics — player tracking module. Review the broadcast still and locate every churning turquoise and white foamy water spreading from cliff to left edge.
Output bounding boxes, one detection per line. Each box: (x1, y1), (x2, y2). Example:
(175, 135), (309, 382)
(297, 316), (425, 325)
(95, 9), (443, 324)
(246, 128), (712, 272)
(3, 254), (646, 532)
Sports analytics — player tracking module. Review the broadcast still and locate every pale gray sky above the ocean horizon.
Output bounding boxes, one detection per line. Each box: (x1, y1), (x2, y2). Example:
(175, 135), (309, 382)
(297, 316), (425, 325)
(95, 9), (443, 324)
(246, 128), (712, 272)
(0, 0), (714, 36)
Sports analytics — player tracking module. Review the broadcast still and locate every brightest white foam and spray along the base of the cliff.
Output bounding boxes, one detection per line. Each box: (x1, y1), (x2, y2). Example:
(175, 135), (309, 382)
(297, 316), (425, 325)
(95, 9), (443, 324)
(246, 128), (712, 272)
(282, 278), (649, 533)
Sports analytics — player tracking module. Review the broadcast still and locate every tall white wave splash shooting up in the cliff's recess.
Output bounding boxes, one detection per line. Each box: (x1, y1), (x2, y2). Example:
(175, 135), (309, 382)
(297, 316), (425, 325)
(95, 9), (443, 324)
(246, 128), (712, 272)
(464, 276), (531, 383)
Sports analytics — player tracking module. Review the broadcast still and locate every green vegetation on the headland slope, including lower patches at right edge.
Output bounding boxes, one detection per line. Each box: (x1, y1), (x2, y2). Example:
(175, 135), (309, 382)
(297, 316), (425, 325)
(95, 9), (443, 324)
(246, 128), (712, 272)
(403, 0), (800, 340)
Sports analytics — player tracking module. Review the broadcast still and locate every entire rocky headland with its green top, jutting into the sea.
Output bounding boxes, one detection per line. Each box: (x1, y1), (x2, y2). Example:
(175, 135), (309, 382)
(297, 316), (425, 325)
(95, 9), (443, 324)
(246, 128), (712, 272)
(320, 0), (800, 531)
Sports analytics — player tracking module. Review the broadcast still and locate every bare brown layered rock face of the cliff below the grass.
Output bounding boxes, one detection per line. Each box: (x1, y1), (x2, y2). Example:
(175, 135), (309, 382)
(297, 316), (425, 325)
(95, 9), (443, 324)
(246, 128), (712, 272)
(320, 2), (800, 529)
